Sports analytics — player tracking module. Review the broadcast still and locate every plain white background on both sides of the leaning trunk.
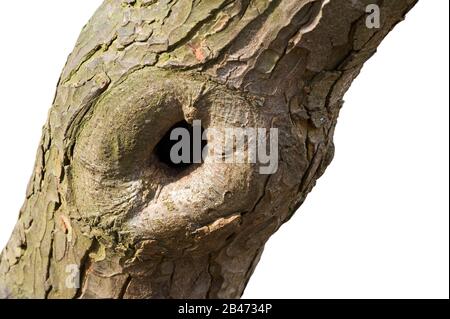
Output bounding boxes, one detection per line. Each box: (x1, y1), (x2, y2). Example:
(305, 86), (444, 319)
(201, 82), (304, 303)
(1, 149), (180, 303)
(0, 0), (449, 298)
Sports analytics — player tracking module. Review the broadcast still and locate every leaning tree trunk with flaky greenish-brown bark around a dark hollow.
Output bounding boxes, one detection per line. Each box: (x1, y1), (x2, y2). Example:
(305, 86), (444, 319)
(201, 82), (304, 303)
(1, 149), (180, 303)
(0, 0), (416, 298)
